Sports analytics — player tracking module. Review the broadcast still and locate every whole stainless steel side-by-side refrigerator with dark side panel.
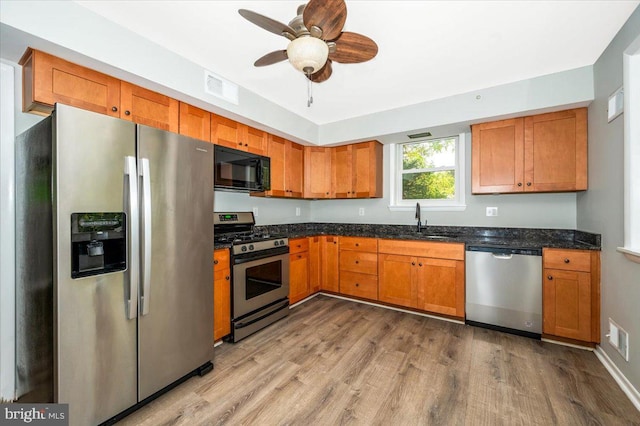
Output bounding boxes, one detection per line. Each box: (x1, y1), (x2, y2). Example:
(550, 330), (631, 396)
(16, 104), (213, 425)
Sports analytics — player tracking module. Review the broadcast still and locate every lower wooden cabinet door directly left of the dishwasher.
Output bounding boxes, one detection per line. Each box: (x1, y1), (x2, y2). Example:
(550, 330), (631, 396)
(417, 258), (464, 318)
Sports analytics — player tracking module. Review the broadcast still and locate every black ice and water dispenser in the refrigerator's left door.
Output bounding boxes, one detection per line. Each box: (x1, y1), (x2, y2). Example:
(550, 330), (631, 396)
(71, 212), (127, 278)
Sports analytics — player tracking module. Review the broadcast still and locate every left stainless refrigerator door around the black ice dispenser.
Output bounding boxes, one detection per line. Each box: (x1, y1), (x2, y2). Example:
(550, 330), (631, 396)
(53, 105), (137, 425)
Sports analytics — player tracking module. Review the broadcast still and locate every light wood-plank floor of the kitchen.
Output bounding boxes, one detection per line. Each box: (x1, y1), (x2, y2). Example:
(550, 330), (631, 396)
(120, 295), (640, 426)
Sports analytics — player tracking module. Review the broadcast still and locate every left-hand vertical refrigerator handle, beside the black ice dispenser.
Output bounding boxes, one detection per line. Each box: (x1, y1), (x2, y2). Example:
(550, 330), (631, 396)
(124, 156), (140, 319)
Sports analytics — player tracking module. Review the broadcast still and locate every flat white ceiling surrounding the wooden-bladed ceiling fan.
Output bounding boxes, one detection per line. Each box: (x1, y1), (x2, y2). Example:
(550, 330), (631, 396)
(45, 0), (640, 125)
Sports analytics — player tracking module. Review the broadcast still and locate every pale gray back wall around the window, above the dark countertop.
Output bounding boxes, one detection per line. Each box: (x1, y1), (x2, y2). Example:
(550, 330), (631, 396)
(311, 143), (576, 229)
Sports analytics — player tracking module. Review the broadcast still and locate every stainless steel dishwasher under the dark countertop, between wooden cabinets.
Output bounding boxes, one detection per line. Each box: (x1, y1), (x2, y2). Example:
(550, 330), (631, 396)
(465, 246), (542, 339)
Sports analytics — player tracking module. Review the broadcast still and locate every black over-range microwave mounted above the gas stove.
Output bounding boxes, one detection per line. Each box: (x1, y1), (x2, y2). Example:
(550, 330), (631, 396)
(213, 145), (271, 192)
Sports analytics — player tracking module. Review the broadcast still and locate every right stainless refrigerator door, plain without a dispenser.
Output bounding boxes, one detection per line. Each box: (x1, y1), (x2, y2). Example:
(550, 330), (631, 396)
(138, 126), (213, 400)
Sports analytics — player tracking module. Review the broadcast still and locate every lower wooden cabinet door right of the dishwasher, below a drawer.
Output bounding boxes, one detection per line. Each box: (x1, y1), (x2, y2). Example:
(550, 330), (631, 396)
(542, 269), (591, 342)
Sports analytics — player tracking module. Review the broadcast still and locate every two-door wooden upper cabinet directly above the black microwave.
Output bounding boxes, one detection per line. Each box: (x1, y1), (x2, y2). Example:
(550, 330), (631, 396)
(211, 113), (268, 155)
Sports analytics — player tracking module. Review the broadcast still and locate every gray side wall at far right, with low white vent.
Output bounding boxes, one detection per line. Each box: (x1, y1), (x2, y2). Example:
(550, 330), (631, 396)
(577, 9), (640, 390)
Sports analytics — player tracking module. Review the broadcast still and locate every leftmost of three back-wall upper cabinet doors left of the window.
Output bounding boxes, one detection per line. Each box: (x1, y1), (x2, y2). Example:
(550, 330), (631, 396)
(304, 146), (331, 198)
